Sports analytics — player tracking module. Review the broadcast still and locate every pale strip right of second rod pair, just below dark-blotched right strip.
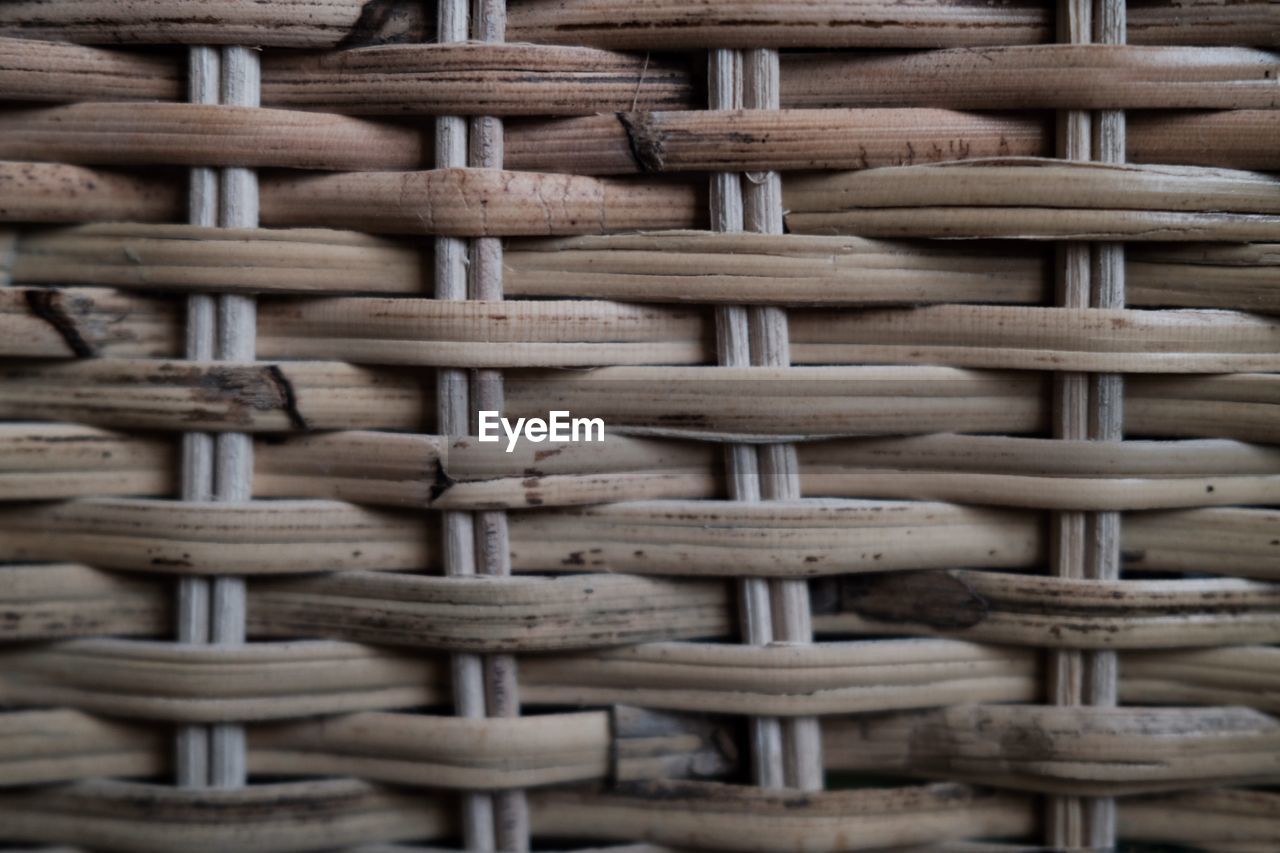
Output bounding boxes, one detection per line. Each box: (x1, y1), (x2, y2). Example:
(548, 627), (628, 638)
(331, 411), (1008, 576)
(532, 639), (1280, 716)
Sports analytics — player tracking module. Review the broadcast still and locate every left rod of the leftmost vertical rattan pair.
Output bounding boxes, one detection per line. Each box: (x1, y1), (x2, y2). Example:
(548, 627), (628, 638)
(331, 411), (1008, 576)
(174, 41), (221, 788)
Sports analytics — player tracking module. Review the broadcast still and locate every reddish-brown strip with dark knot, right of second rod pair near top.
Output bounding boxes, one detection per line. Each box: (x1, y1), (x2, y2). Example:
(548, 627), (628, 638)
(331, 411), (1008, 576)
(506, 109), (1280, 175)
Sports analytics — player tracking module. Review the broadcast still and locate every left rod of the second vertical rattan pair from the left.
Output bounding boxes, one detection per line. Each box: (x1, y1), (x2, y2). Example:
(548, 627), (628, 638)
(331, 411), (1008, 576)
(435, 0), (497, 850)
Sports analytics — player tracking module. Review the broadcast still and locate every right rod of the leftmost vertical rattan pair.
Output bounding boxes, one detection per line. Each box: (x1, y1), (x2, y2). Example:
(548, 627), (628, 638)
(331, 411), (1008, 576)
(209, 46), (262, 788)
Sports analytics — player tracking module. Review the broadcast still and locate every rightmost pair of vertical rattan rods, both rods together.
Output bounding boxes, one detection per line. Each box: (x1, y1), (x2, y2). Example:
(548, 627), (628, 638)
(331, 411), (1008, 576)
(1047, 0), (1124, 849)
